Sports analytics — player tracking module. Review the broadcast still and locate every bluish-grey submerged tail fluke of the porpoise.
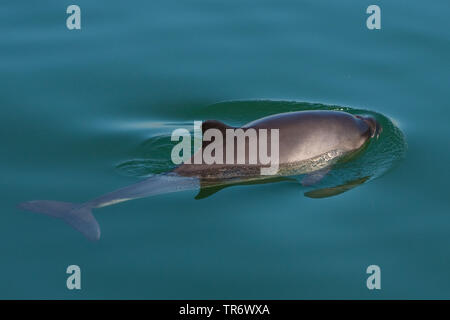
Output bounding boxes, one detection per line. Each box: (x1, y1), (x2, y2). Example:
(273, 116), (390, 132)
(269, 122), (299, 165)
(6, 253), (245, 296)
(19, 200), (100, 241)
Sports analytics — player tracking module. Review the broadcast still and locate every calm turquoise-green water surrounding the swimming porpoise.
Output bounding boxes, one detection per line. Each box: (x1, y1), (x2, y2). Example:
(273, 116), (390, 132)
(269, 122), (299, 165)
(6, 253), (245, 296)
(0, 0), (450, 299)
